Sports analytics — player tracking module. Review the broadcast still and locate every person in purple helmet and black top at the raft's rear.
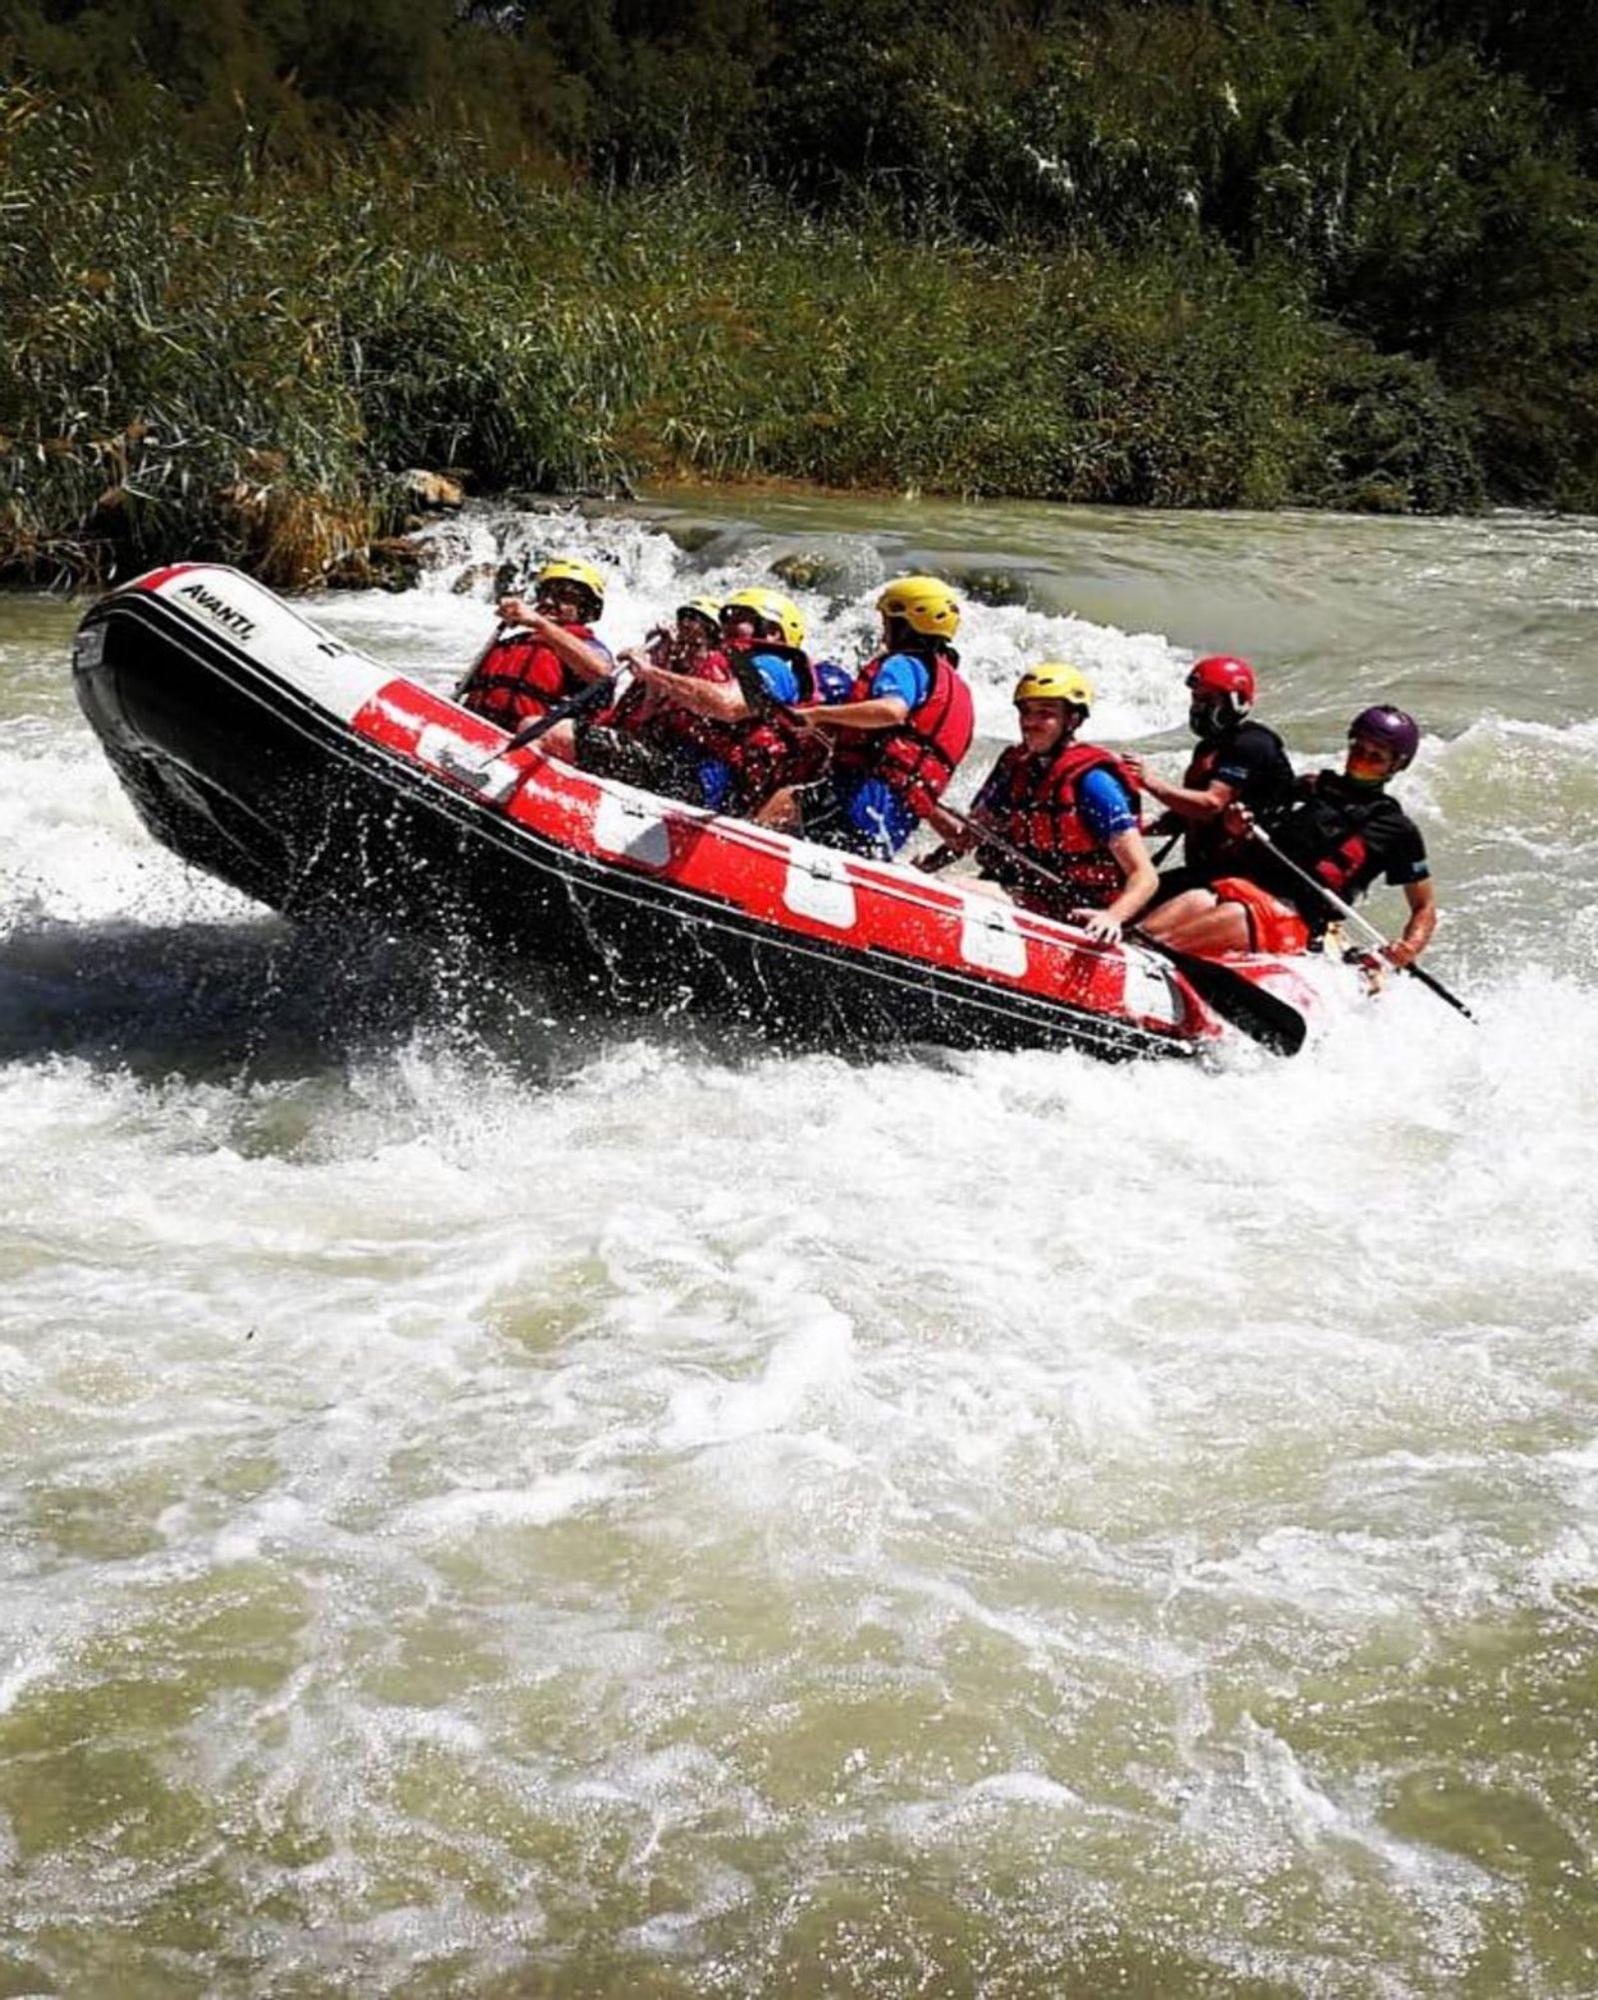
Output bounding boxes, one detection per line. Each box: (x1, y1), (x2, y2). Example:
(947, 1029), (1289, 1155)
(1144, 704), (1438, 968)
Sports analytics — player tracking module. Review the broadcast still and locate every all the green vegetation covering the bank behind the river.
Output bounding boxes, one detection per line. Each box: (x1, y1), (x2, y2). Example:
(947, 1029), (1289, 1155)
(0, 0), (1598, 584)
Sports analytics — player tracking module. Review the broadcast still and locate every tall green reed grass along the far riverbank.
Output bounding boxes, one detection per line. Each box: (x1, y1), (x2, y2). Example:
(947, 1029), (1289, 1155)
(0, 86), (1480, 586)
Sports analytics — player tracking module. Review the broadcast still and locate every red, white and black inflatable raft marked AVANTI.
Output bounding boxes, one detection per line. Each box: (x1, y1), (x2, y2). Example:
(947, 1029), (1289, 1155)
(74, 564), (1314, 1056)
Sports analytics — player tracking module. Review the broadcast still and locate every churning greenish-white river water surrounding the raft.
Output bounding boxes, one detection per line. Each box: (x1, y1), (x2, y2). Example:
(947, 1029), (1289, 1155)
(0, 496), (1598, 2000)
